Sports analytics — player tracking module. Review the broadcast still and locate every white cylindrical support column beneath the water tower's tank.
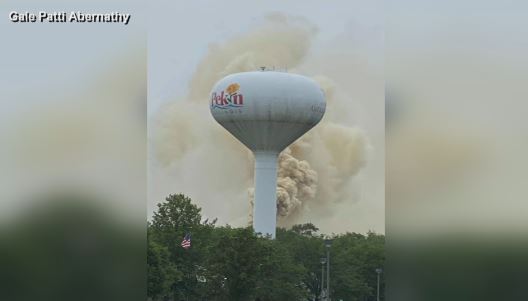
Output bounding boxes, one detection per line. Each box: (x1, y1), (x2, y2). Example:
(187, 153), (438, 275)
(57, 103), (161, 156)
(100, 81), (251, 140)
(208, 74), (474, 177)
(253, 151), (278, 239)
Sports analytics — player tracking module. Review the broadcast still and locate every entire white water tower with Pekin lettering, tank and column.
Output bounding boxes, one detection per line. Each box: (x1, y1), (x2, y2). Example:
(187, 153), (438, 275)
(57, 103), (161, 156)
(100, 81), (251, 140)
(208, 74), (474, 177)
(210, 70), (326, 238)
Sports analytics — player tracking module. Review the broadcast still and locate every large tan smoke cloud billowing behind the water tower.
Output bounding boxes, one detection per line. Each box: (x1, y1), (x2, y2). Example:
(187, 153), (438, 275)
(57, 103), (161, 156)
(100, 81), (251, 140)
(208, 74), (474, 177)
(150, 14), (369, 226)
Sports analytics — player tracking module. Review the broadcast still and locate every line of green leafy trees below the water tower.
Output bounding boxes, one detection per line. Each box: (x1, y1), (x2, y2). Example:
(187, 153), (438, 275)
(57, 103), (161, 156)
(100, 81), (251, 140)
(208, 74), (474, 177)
(147, 194), (385, 301)
